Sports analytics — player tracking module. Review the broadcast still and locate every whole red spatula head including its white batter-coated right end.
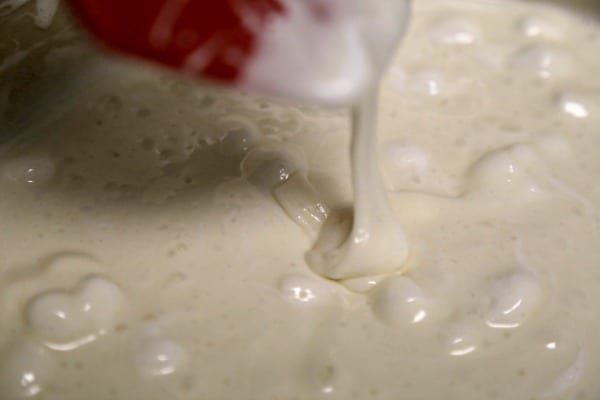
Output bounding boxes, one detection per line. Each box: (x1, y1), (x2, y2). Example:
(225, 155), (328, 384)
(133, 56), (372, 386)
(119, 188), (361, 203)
(70, 0), (407, 104)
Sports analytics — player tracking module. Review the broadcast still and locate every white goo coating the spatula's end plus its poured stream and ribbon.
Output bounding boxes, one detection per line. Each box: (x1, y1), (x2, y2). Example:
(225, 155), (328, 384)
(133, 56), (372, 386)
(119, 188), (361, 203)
(234, 0), (408, 279)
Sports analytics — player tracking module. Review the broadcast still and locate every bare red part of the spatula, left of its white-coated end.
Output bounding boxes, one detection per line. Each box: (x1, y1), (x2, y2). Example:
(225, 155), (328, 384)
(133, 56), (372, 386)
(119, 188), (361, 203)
(71, 0), (285, 83)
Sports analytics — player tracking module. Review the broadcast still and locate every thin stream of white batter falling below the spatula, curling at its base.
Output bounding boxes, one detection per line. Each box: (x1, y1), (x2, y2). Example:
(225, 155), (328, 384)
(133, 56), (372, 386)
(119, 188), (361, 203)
(307, 90), (408, 279)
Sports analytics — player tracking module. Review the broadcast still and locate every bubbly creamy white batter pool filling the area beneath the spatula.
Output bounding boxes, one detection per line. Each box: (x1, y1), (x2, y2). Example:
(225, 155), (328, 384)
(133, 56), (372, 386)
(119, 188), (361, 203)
(0, 0), (600, 400)
